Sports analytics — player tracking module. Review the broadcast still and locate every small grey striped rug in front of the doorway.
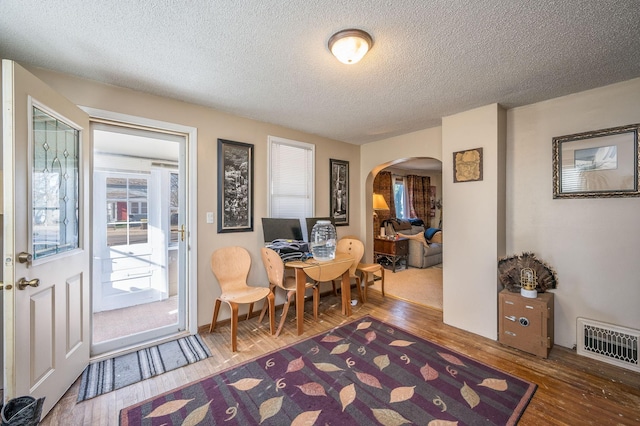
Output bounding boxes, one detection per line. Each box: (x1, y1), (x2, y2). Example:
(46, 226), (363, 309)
(78, 334), (211, 402)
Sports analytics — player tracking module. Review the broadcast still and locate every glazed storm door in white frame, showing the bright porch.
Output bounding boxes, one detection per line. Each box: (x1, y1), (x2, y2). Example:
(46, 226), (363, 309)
(91, 123), (187, 356)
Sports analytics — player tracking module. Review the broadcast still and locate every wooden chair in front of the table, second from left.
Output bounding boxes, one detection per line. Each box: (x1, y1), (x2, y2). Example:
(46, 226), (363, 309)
(260, 247), (320, 337)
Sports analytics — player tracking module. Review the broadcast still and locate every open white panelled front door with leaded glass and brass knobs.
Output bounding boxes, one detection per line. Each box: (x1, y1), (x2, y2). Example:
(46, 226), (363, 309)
(2, 60), (90, 416)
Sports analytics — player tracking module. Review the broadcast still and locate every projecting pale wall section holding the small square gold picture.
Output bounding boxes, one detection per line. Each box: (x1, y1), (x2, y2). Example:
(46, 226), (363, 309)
(442, 104), (506, 340)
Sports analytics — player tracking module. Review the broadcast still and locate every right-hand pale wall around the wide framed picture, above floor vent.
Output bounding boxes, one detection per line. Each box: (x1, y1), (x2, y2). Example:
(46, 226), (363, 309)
(507, 79), (640, 347)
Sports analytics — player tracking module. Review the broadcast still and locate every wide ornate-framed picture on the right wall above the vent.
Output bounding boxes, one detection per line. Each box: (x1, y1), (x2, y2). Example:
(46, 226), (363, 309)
(553, 124), (640, 198)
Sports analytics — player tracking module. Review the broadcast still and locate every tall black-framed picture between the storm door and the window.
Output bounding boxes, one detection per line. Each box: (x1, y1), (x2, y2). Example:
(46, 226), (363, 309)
(218, 139), (253, 233)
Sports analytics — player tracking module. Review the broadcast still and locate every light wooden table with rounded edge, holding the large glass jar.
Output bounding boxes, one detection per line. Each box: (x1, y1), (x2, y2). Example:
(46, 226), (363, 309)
(285, 253), (353, 335)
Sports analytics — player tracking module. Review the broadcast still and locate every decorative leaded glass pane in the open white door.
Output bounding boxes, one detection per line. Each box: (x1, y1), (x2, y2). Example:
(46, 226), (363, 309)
(31, 107), (80, 260)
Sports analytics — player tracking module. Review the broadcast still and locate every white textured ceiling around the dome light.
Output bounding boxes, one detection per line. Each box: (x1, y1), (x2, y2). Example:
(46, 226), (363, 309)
(0, 0), (640, 144)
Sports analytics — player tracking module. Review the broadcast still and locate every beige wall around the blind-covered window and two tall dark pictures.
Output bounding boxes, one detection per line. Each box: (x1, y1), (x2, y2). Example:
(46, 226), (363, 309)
(29, 68), (361, 325)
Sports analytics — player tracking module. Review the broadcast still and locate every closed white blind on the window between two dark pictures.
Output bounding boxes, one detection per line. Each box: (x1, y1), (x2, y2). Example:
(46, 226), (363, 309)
(269, 136), (315, 218)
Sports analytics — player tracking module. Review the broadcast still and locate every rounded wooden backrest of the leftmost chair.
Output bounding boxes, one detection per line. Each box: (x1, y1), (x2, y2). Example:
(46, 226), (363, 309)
(211, 246), (251, 293)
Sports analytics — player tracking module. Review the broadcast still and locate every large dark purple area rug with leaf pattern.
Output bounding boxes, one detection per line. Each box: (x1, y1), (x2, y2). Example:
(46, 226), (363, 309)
(120, 317), (536, 426)
